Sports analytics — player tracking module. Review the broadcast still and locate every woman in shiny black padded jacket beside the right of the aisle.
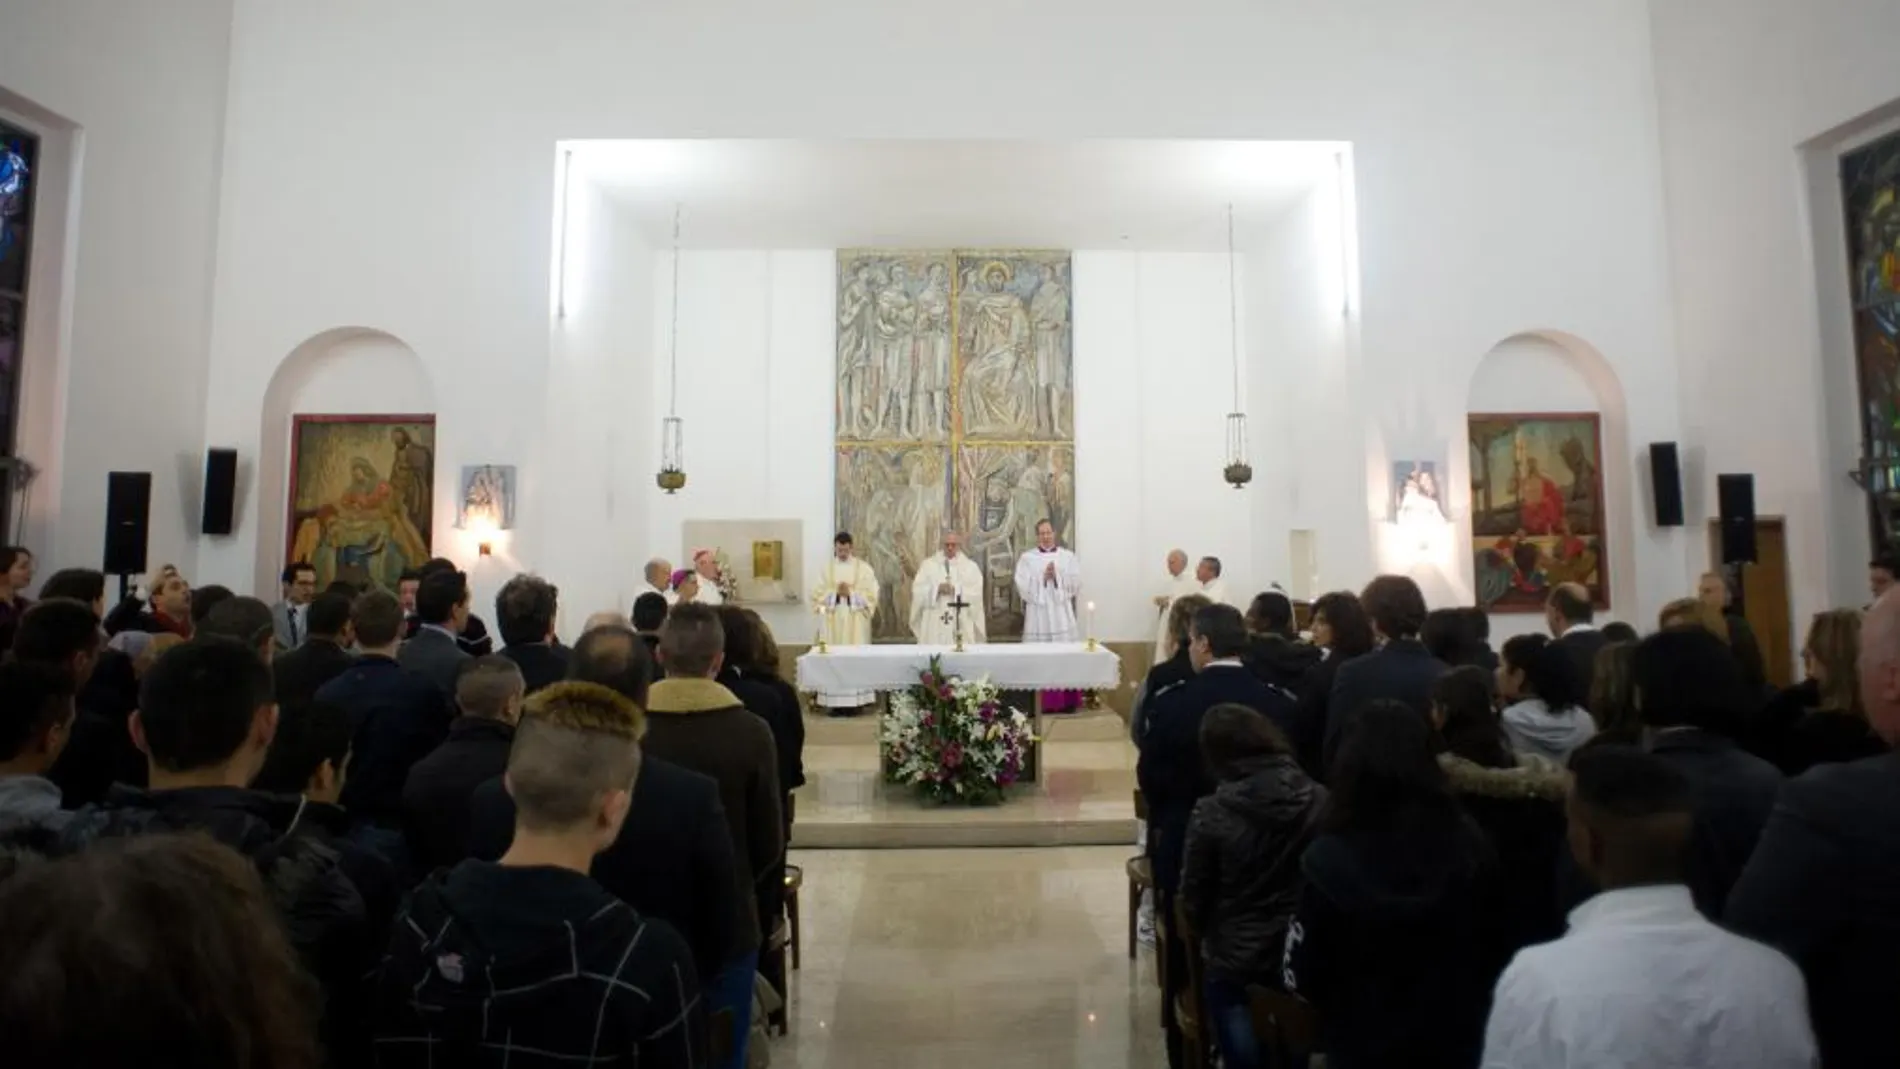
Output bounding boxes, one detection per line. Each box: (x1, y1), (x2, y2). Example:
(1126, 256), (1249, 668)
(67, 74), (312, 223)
(1180, 704), (1326, 1069)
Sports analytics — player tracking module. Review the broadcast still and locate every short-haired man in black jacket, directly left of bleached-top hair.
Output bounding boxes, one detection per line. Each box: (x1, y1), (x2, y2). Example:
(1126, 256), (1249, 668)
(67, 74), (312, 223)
(403, 655), (526, 872)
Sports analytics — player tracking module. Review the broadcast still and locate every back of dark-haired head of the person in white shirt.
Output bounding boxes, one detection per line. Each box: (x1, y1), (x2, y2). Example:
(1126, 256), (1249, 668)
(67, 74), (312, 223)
(1568, 746), (1695, 891)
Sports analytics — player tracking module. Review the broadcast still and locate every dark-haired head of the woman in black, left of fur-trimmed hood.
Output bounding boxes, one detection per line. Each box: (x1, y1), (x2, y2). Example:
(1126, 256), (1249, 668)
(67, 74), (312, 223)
(1324, 701), (1457, 834)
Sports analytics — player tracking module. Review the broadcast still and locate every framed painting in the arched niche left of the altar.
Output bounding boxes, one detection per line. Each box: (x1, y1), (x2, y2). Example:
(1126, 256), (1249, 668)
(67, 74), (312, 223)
(285, 416), (435, 591)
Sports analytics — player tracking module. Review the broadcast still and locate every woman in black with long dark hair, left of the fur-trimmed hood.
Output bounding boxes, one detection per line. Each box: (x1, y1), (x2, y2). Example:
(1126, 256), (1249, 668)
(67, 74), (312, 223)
(1284, 701), (1495, 1069)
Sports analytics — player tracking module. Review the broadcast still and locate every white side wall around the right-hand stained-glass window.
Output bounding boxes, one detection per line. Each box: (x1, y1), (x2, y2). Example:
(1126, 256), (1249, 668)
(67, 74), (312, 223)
(1649, 0), (1900, 634)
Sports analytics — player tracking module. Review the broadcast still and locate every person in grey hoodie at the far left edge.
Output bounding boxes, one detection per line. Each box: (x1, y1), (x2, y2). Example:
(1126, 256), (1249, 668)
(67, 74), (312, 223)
(0, 657), (74, 834)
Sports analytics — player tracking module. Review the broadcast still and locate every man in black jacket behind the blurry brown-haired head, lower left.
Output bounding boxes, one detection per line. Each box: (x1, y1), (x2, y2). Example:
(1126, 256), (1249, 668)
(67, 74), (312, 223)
(57, 638), (371, 1065)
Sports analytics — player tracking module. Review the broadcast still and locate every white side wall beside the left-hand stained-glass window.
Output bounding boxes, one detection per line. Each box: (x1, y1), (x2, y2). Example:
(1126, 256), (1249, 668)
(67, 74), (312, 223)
(0, 0), (233, 573)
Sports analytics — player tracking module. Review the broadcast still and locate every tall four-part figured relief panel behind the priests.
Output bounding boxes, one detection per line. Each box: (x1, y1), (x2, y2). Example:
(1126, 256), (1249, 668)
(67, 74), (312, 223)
(836, 249), (1075, 642)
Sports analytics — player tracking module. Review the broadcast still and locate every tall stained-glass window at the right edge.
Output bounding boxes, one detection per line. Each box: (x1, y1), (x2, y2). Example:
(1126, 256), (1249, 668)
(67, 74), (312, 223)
(1841, 133), (1900, 545)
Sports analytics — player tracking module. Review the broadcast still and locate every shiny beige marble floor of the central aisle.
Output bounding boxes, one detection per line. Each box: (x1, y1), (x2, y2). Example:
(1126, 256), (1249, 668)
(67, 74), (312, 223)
(771, 847), (1167, 1069)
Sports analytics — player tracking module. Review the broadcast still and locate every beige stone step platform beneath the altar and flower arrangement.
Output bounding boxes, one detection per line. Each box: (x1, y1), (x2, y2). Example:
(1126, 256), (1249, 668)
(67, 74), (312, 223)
(792, 710), (1134, 849)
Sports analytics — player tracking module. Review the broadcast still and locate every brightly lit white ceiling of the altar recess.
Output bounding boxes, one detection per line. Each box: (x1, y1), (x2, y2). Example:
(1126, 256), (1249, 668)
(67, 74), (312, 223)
(564, 141), (1345, 251)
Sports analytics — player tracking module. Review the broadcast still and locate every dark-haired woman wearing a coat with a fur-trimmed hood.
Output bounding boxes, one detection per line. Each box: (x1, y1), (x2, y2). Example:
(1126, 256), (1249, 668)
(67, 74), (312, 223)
(1431, 665), (1569, 960)
